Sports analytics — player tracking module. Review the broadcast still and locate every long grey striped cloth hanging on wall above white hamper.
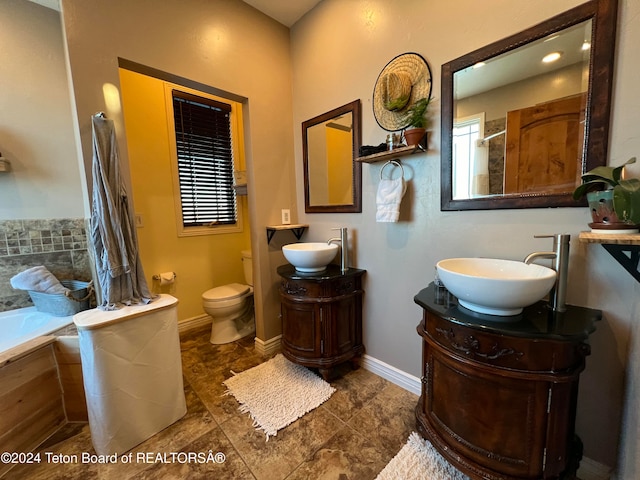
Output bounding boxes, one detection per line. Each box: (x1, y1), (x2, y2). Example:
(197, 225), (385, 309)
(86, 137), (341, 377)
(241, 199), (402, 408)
(91, 113), (152, 310)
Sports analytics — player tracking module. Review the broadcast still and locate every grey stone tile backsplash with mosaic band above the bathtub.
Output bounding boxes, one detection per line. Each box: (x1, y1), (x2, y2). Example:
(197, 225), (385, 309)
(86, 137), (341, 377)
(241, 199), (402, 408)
(0, 218), (91, 311)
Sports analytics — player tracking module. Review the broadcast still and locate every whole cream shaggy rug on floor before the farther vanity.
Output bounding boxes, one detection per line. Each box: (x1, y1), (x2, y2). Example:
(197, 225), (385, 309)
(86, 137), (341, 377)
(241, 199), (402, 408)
(223, 354), (336, 440)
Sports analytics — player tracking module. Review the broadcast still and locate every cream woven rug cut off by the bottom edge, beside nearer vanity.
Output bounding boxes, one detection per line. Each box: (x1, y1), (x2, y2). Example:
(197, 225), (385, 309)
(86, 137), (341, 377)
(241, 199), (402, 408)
(376, 432), (469, 480)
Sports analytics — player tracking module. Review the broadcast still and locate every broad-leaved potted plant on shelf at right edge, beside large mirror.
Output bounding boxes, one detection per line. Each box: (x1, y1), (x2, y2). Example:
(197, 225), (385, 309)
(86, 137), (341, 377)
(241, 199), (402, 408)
(573, 157), (640, 231)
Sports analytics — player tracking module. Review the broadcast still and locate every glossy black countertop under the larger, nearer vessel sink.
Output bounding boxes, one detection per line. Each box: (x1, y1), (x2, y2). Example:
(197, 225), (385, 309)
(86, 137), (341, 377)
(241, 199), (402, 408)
(414, 283), (602, 340)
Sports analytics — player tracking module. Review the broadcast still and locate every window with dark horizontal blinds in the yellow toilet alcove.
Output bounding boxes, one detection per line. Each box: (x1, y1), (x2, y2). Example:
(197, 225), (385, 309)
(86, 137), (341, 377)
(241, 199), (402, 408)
(172, 90), (237, 229)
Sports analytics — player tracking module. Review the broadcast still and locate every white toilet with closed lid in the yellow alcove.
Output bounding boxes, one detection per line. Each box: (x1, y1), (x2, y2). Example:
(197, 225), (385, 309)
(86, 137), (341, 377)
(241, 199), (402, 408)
(202, 250), (256, 345)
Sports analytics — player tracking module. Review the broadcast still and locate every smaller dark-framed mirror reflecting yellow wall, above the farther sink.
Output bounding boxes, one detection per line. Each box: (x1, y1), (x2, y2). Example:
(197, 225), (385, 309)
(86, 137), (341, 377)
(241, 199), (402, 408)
(302, 100), (362, 213)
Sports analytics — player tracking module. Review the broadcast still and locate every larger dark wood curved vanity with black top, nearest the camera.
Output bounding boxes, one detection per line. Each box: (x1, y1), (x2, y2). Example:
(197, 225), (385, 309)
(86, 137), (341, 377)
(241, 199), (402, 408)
(414, 284), (601, 480)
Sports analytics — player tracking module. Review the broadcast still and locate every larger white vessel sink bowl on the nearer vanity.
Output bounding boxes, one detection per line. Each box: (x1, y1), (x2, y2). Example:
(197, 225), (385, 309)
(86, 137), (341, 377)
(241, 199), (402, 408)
(436, 258), (556, 316)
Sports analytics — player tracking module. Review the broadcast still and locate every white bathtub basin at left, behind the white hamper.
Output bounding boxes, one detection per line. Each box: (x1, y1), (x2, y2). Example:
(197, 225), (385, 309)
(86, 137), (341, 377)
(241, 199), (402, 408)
(0, 307), (73, 355)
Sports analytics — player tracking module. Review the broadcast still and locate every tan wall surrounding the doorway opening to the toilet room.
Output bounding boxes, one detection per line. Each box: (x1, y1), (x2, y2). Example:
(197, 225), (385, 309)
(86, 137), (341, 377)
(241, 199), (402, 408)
(62, 0), (296, 340)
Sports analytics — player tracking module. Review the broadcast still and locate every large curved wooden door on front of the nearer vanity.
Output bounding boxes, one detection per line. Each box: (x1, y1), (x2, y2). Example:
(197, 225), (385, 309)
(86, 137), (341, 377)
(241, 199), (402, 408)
(424, 346), (548, 478)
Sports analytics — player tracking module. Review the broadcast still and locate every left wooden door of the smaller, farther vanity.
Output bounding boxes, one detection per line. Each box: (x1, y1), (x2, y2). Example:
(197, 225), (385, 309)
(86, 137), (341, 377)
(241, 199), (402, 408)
(281, 298), (322, 358)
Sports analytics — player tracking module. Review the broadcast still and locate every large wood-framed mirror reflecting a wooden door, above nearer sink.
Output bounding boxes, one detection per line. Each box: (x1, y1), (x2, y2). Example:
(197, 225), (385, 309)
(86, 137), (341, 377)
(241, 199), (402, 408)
(441, 0), (617, 210)
